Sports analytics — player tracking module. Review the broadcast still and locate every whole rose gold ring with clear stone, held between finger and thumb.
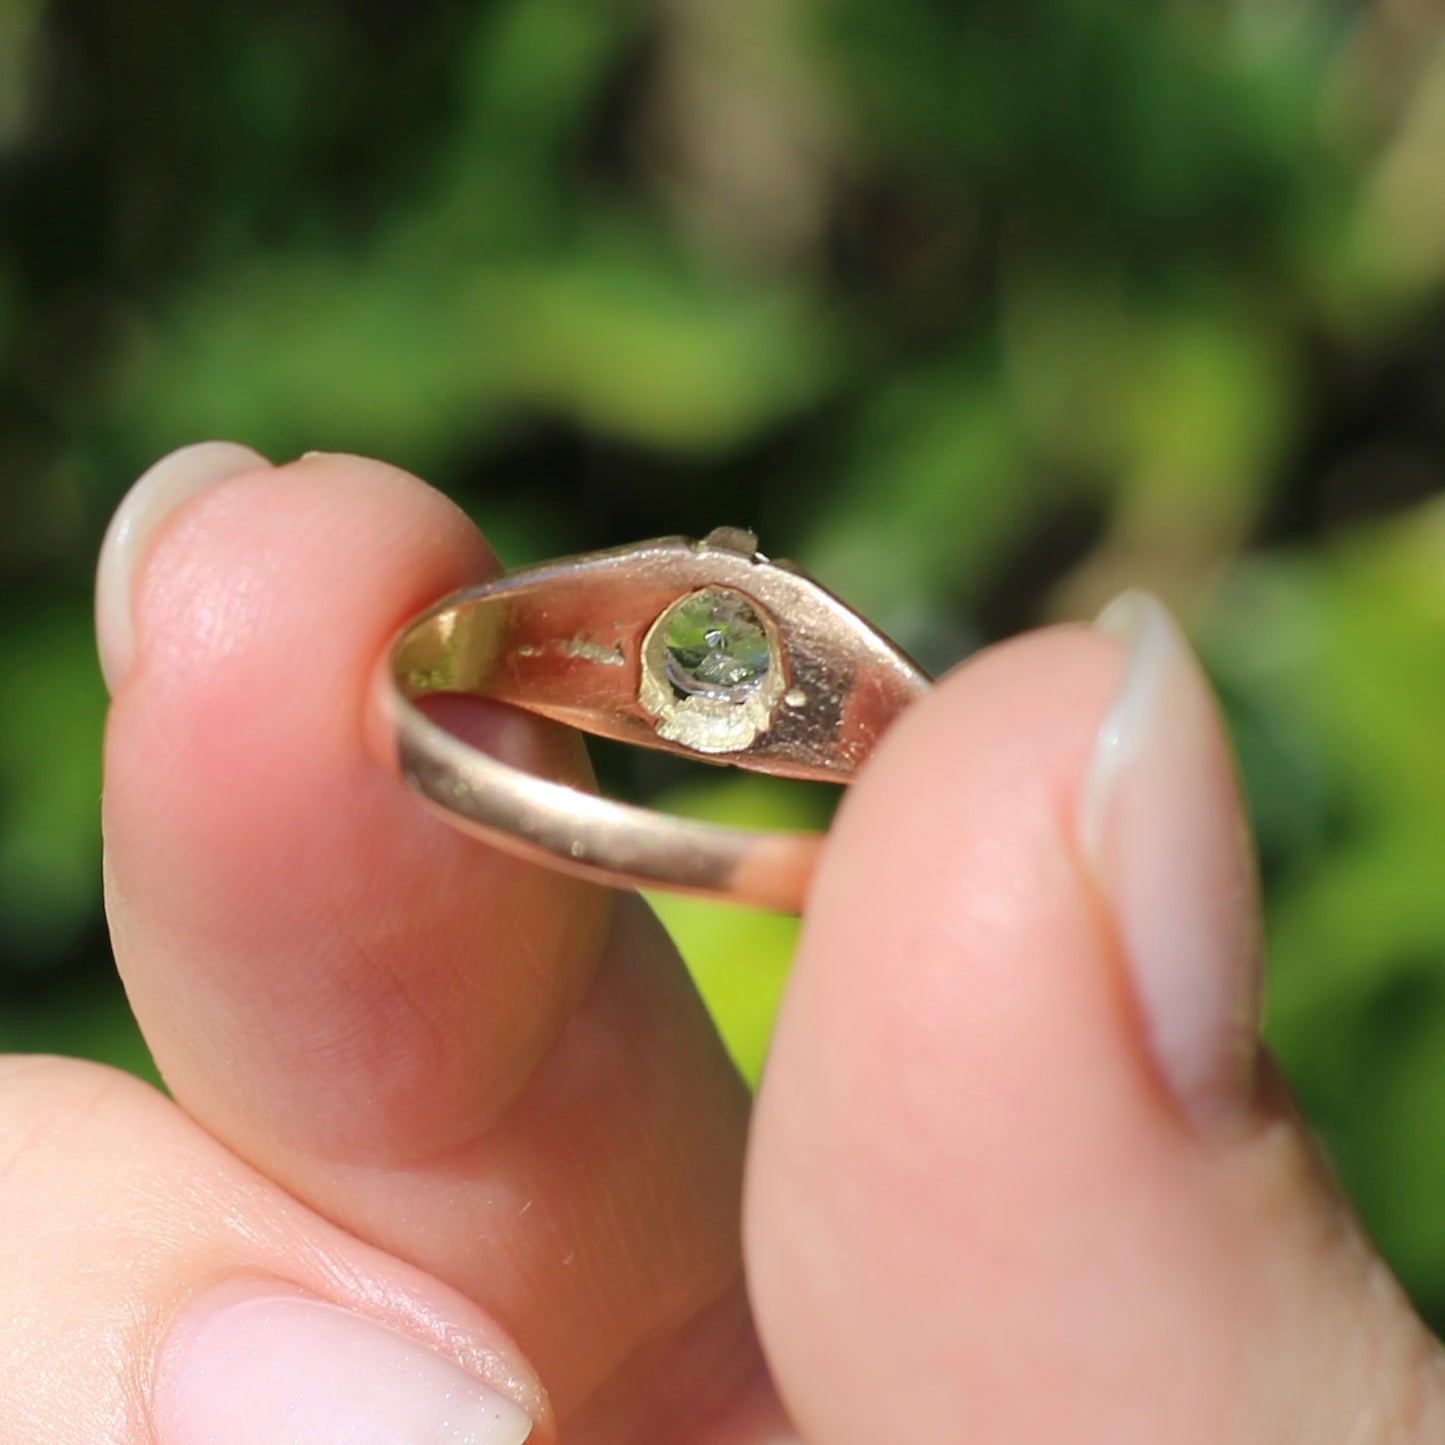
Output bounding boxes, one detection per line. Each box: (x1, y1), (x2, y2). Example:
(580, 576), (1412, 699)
(383, 527), (929, 912)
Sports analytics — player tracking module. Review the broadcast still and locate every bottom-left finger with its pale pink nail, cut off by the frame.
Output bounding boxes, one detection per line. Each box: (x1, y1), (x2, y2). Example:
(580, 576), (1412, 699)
(0, 1058), (556, 1445)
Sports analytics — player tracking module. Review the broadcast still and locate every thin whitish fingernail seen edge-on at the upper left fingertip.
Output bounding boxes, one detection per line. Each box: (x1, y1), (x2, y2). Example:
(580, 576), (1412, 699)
(95, 442), (270, 692)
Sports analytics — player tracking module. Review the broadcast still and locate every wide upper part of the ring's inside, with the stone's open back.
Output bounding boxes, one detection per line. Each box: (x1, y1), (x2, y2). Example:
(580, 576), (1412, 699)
(393, 538), (928, 782)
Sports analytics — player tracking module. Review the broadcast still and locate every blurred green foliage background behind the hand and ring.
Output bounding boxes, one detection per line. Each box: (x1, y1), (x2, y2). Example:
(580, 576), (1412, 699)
(0, 0), (1445, 1327)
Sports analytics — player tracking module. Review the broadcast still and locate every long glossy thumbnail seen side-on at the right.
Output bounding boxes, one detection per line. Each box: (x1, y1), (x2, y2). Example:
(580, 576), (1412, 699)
(1079, 592), (1261, 1127)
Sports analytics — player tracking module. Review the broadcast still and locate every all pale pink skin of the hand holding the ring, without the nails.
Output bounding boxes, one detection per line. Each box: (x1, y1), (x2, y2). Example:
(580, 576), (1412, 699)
(0, 445), (1445, 1445)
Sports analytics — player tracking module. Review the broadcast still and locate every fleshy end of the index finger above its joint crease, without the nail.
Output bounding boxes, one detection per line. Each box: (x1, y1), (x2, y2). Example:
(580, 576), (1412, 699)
(104, 455), (608, 1152)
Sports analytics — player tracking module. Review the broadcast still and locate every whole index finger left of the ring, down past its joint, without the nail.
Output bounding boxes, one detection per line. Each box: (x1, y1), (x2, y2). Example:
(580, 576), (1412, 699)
(105, 457), (756, 1438)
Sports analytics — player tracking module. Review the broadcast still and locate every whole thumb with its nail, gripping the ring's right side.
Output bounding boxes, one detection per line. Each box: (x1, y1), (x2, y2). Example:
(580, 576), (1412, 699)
(747, 597), (1445, 1445)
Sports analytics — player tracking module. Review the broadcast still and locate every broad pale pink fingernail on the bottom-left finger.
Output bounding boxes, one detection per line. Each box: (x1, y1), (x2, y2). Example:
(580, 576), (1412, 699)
(155, 1285), (532, 1445)
